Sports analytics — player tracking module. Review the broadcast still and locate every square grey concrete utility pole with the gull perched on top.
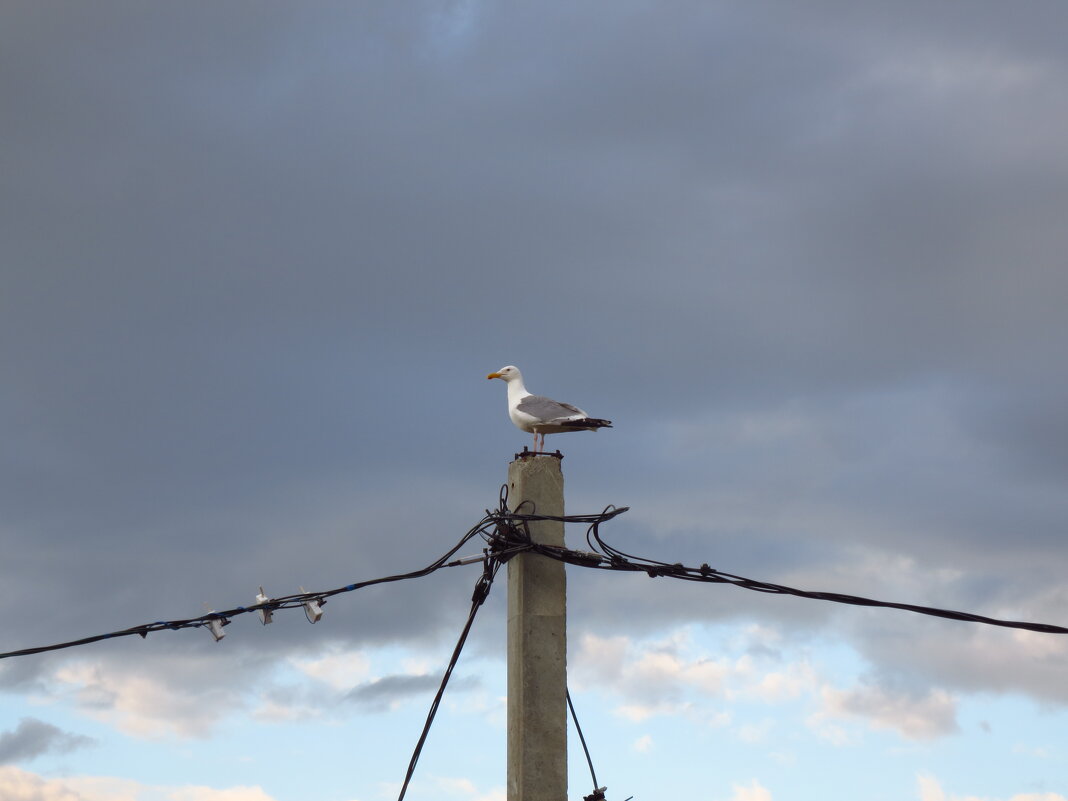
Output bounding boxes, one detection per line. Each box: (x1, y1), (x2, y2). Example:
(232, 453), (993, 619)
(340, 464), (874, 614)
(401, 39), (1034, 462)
(507, 455), (567, 801)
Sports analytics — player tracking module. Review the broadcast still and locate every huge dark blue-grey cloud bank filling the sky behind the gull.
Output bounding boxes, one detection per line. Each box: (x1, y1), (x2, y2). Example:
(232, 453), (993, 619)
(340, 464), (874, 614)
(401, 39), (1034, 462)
(0, 1), (1068, 713)
